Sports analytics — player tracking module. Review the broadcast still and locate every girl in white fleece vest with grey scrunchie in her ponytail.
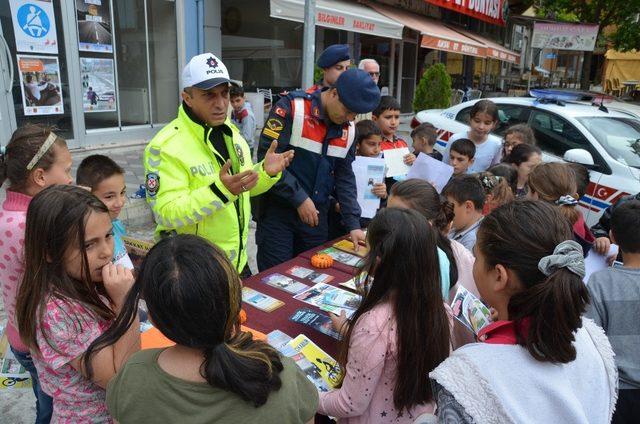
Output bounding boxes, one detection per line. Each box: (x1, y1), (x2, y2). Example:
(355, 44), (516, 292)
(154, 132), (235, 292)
(430, 200), (617, 423)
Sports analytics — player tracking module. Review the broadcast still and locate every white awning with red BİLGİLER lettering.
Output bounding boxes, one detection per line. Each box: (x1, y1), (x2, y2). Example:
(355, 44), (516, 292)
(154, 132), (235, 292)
(270, 0), (403, 39)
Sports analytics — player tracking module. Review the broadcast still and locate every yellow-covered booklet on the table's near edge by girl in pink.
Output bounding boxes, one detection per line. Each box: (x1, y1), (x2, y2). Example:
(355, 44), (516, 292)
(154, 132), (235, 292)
(288, 334), (340, 392)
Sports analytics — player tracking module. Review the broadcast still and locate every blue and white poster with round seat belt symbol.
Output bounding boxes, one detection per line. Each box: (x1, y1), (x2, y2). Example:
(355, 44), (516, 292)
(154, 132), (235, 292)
(9, 0), (58, 54)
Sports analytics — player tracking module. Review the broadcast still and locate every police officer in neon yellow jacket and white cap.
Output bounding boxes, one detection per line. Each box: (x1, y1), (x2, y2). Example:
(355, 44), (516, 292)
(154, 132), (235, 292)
(144, 53), (293, 276)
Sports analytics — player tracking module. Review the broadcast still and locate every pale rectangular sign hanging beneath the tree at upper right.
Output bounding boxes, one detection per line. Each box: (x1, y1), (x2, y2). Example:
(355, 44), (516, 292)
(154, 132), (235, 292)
(531, 22), (599, 52)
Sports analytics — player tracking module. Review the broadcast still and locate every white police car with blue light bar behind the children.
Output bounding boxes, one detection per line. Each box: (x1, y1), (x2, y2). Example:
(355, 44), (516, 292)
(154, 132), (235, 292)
(411, 93), (640, 226)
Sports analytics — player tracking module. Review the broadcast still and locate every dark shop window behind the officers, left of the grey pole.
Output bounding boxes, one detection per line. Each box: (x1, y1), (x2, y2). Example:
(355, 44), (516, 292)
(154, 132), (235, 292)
(222, 0), (303, 92)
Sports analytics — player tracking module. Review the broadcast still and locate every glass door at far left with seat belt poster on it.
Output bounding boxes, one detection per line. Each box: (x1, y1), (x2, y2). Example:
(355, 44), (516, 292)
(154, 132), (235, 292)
(0, 0), (74, 144)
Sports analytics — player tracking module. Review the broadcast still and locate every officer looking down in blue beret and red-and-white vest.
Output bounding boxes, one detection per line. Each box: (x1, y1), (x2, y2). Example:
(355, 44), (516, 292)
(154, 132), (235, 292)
(256, 69), (380, 271)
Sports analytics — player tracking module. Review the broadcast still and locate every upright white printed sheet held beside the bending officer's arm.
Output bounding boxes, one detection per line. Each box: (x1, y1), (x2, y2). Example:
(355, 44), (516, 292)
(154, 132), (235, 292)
(351, 156), (385, 218)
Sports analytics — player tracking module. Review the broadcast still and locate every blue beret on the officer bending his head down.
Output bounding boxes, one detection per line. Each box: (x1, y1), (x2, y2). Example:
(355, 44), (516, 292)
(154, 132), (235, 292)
(336, 69), (380, 113)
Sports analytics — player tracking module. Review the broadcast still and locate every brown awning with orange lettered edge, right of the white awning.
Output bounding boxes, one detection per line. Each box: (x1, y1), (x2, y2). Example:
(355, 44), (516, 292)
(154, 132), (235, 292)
(369, 3), (486, 57)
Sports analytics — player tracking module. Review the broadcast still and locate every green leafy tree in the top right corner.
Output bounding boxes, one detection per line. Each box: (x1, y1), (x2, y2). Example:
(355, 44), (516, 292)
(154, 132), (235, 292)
(536, 0), (640, 89)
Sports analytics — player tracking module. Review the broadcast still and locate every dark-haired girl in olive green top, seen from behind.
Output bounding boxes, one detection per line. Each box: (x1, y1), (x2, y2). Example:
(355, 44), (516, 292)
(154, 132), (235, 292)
(107, 235), (318, 424)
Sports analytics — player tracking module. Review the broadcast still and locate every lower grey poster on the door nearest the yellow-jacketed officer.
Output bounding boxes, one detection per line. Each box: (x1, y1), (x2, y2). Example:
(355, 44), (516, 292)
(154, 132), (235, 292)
(80, 57), (116, 113)
